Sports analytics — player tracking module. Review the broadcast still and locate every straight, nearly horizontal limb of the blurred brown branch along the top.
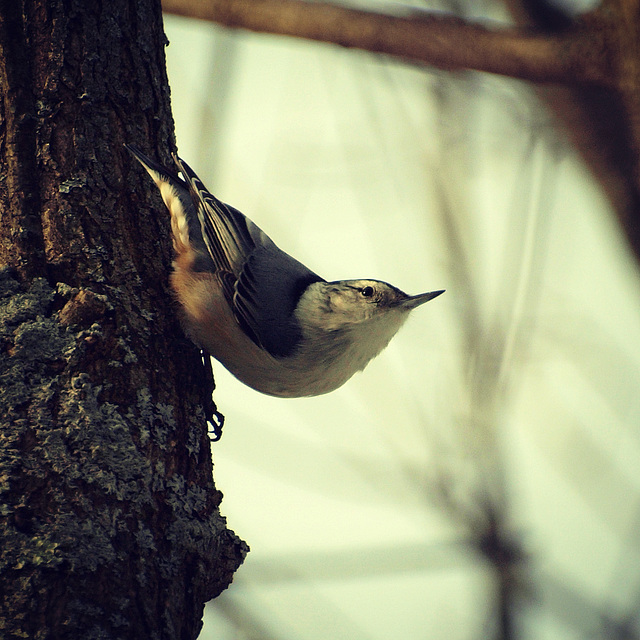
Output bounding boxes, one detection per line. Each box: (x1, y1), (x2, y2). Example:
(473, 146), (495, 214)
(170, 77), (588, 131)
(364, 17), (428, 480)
(162, 0), (612, 85)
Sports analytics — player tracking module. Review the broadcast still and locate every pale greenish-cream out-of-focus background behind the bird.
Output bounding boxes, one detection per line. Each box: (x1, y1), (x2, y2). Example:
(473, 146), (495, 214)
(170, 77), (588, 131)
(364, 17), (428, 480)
(165, 3), (640, 640)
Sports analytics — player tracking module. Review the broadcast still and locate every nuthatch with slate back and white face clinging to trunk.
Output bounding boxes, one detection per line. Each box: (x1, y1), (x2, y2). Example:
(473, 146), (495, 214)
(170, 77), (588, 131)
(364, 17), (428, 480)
(125, 145), (443, 398)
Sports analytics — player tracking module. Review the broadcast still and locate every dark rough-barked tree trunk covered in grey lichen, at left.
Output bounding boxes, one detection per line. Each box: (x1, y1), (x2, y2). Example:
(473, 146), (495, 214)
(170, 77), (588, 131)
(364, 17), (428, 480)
(0, 0), (247, 640)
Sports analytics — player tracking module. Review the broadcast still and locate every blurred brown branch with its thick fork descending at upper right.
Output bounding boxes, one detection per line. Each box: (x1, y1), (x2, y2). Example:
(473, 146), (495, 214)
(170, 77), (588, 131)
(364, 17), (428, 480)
(163, 0), (640, 260)
